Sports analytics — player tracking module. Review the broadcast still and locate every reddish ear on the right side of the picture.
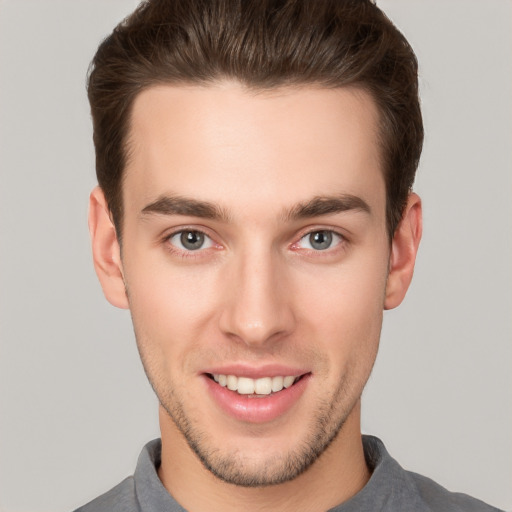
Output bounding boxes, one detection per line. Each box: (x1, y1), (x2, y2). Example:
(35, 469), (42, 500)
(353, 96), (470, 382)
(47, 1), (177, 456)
(384, 193), (423, 309)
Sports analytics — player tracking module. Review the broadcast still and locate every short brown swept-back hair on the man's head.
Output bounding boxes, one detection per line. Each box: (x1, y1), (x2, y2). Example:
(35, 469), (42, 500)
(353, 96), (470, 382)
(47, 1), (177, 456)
(88, 0), (423, 236)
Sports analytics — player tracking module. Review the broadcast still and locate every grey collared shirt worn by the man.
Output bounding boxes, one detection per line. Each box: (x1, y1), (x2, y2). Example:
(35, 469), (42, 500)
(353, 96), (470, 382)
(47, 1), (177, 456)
(75, 436), (500, 512)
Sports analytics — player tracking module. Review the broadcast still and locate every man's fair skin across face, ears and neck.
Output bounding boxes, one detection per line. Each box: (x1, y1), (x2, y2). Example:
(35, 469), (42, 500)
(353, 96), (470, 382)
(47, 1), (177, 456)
(89, 83), (421, 512)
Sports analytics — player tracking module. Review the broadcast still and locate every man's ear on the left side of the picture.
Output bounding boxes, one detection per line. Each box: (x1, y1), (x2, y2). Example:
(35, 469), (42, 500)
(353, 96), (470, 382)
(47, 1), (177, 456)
(89, 187), (128, 309)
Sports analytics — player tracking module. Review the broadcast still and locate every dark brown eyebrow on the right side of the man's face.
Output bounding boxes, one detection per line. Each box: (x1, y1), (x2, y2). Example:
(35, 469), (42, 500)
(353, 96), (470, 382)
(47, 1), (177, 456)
(285, 194), (371, 220)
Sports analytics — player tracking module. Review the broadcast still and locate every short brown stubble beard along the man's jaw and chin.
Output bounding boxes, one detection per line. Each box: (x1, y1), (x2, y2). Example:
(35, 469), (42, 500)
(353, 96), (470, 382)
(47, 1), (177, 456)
(128, 304), (376, 488)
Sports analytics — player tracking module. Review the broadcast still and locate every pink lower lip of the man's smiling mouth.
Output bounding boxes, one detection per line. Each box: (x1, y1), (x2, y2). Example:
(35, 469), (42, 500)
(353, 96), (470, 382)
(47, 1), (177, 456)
(204, 374), (311, 423)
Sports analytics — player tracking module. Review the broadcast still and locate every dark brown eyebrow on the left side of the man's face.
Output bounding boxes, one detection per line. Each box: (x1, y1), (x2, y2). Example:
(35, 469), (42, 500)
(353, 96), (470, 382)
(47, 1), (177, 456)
(141, 196), (229, 222)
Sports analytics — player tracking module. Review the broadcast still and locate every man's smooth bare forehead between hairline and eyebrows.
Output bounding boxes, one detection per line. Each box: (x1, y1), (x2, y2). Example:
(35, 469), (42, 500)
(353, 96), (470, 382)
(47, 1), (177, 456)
(123, 82), (385, 218)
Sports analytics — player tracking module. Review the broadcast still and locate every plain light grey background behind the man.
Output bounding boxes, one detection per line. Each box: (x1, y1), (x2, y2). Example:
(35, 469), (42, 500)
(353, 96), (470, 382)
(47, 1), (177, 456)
(0, 0), (512, 512)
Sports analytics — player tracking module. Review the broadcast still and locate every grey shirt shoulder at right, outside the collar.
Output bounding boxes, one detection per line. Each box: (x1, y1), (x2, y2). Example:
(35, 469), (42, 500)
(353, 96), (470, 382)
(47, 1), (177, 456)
(406, 471), (500, 512)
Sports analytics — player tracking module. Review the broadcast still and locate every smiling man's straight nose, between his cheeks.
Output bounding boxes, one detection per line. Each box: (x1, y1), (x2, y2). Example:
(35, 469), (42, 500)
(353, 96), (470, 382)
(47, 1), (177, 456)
(220, 250), (295, 347)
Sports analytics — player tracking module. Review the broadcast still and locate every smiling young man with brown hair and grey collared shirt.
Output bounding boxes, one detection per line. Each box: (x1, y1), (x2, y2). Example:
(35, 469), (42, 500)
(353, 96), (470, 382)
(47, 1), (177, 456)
(80, 0), (504, 512)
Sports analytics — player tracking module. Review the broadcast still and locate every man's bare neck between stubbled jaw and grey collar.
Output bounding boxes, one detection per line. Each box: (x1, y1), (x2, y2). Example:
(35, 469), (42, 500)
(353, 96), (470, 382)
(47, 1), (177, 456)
(158, 402), (370, 512)
